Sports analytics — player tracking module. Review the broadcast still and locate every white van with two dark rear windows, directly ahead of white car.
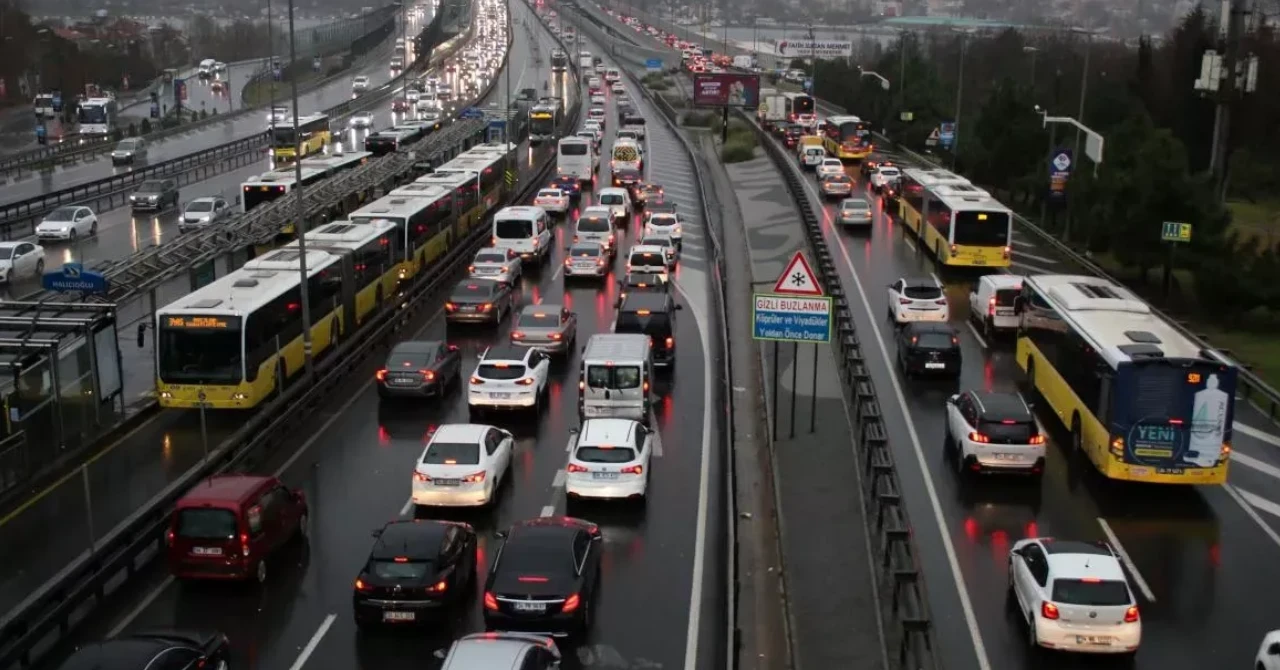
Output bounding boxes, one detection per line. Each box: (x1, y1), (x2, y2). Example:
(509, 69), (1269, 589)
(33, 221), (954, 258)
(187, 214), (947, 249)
(577, 333), (653, 425)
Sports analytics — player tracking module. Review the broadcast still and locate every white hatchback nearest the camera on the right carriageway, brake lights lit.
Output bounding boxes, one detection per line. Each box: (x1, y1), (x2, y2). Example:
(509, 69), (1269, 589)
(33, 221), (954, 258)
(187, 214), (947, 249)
(1009, 538), (1142, 655)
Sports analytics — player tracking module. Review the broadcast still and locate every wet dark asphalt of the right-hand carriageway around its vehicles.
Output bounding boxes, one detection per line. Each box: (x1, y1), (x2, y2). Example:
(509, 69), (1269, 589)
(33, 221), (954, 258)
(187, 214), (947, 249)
(827, 163), (1280, 667)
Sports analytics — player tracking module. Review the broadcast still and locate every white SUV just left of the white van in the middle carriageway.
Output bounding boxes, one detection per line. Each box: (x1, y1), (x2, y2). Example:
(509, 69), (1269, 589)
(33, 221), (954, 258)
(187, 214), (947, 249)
(467, 345), (552, 416)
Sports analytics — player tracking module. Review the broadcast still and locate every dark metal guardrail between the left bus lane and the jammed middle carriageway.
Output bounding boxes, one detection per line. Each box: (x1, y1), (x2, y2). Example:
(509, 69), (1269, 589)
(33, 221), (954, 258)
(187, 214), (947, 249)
(0, 13), (570, 670)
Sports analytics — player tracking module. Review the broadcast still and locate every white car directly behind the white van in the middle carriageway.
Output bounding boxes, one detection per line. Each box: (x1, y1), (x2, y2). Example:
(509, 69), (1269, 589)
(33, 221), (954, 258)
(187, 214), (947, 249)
(564, 419), (653, 501)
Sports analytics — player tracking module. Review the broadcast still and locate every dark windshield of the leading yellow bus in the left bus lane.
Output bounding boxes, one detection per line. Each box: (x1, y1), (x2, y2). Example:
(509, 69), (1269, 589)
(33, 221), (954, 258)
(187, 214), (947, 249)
(157, 324), (243, 384)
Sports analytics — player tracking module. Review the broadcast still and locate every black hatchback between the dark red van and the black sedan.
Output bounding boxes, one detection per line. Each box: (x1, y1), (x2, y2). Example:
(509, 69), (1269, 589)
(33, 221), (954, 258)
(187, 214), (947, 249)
(351, 519), (476, 626)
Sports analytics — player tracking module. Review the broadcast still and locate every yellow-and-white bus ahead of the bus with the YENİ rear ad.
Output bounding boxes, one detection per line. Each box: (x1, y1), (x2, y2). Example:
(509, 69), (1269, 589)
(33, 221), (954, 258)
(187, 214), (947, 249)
(899, 169), (1014, 268)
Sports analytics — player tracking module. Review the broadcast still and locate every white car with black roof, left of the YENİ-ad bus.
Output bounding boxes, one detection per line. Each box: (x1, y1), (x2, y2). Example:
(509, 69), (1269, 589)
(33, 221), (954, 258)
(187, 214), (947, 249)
(945, 391), (1044, 475)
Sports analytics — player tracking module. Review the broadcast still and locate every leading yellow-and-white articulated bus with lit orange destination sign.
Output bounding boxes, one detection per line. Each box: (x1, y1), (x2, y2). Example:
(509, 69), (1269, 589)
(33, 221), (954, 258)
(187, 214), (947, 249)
(155, 249), (350, 410)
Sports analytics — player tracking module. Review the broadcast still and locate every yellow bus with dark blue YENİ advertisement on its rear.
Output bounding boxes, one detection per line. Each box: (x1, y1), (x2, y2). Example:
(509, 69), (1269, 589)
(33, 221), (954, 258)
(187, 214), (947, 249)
(1014, 274), (1238, 484)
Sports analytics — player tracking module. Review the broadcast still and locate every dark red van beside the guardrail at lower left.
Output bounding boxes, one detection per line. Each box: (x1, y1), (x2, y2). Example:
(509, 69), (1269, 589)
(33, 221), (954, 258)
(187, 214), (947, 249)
(168, 474), (307, 583)
